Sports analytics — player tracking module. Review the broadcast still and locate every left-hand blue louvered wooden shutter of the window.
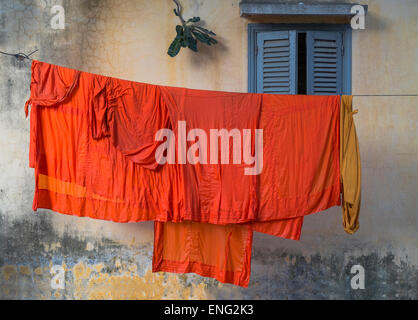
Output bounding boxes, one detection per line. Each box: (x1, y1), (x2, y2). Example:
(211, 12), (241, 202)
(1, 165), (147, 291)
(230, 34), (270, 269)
(257, 31), (297, 94)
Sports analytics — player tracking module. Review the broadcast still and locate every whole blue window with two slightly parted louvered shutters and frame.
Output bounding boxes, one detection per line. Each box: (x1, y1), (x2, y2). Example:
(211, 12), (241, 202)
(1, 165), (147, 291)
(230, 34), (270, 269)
(248, 24), (351, 95)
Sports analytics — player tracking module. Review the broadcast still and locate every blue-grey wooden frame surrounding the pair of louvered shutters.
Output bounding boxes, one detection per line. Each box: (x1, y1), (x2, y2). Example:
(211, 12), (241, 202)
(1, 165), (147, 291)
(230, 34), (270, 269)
(248, 23), (352, 95)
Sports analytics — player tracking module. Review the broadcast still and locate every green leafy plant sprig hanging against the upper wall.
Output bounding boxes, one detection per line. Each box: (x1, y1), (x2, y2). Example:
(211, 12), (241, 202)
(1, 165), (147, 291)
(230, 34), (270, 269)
(167, 0), (218, 57)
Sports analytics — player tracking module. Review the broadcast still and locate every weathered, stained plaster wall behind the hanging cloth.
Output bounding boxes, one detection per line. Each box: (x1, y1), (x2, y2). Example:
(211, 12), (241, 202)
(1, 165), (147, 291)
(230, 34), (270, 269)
(0, 0), (418, 299)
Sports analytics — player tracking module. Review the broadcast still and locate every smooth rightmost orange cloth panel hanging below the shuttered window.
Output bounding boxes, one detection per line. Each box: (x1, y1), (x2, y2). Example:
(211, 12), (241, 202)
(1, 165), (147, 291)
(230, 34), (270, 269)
(257, 94), (340, 221)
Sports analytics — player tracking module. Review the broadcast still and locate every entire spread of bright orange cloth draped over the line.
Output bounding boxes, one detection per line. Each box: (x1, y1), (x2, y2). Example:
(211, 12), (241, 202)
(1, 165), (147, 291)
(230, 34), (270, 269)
(25, 61), (340, 286)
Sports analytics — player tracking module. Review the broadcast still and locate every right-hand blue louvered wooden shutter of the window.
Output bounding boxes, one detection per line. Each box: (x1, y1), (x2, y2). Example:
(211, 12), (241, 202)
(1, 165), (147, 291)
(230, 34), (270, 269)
(307, 31), (343, 95)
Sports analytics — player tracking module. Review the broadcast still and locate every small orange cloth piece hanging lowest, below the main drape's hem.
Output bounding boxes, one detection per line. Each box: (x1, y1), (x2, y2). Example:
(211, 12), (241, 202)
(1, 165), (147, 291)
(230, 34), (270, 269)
(152, 221), (253, 287)
